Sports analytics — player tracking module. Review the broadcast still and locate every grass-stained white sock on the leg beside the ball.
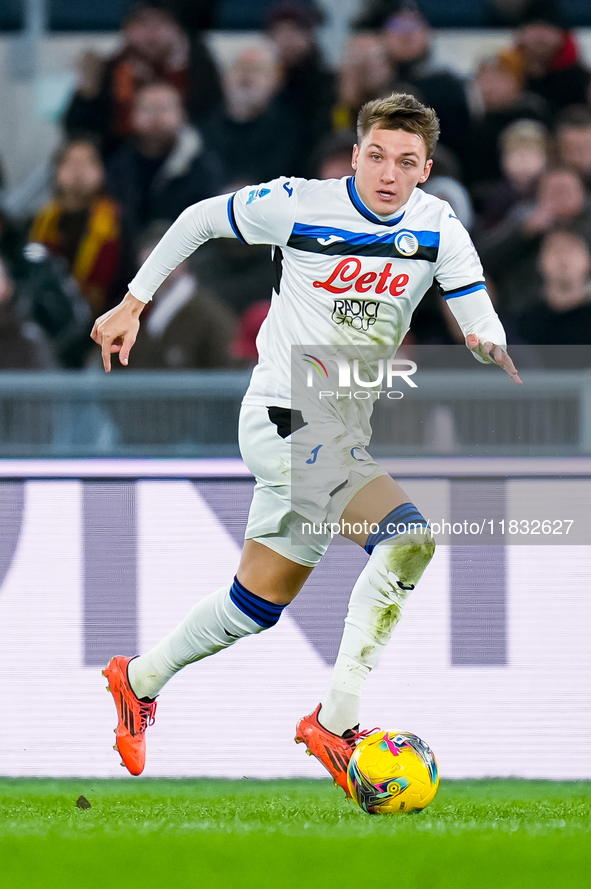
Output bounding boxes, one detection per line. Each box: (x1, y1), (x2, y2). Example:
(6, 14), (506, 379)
(319, 532), (435, 735)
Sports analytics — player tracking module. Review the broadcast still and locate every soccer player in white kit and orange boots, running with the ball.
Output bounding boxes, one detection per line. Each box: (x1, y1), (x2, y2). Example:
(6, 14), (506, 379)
(92, 93), (521, 792)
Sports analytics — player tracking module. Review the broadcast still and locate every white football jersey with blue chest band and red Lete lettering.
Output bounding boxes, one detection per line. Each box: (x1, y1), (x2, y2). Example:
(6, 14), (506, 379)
(129, 176), (505, 418)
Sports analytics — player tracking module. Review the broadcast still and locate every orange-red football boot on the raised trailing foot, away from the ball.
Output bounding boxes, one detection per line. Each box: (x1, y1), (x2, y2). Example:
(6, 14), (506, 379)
(103, 656), (156, 775)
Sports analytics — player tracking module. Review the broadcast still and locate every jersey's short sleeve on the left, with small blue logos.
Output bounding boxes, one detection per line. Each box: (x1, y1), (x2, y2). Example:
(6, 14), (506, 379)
(228, 176), (298, 247)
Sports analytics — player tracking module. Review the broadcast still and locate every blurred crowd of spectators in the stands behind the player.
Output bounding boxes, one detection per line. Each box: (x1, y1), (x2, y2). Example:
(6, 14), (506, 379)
(0, 0), (591, 370)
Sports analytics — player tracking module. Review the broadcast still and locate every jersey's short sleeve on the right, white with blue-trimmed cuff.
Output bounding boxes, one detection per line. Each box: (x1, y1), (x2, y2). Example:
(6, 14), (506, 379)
(434, 203), (484, 295)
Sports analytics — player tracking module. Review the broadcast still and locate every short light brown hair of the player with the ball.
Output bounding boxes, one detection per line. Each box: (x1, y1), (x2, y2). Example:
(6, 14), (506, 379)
(357, 93), (439, 159)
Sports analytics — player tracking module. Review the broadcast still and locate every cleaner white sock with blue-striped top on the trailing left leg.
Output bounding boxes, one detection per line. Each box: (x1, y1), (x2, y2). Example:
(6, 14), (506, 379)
(127, 580), (280, 698)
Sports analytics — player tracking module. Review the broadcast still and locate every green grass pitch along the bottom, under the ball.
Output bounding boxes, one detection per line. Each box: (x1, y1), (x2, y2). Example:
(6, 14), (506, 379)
(0, 779), (591, 889)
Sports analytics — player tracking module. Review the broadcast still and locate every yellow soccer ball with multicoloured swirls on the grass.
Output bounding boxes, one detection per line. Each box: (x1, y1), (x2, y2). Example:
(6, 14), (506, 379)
(347, 732), (439, 815)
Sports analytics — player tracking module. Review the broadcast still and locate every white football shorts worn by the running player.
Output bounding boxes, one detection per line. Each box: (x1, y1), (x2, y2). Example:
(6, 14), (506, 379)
(238, 404), (388, 568)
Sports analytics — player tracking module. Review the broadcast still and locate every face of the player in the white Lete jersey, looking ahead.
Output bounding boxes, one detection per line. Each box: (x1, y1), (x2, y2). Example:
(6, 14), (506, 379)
(352, 127), (433, 216)
